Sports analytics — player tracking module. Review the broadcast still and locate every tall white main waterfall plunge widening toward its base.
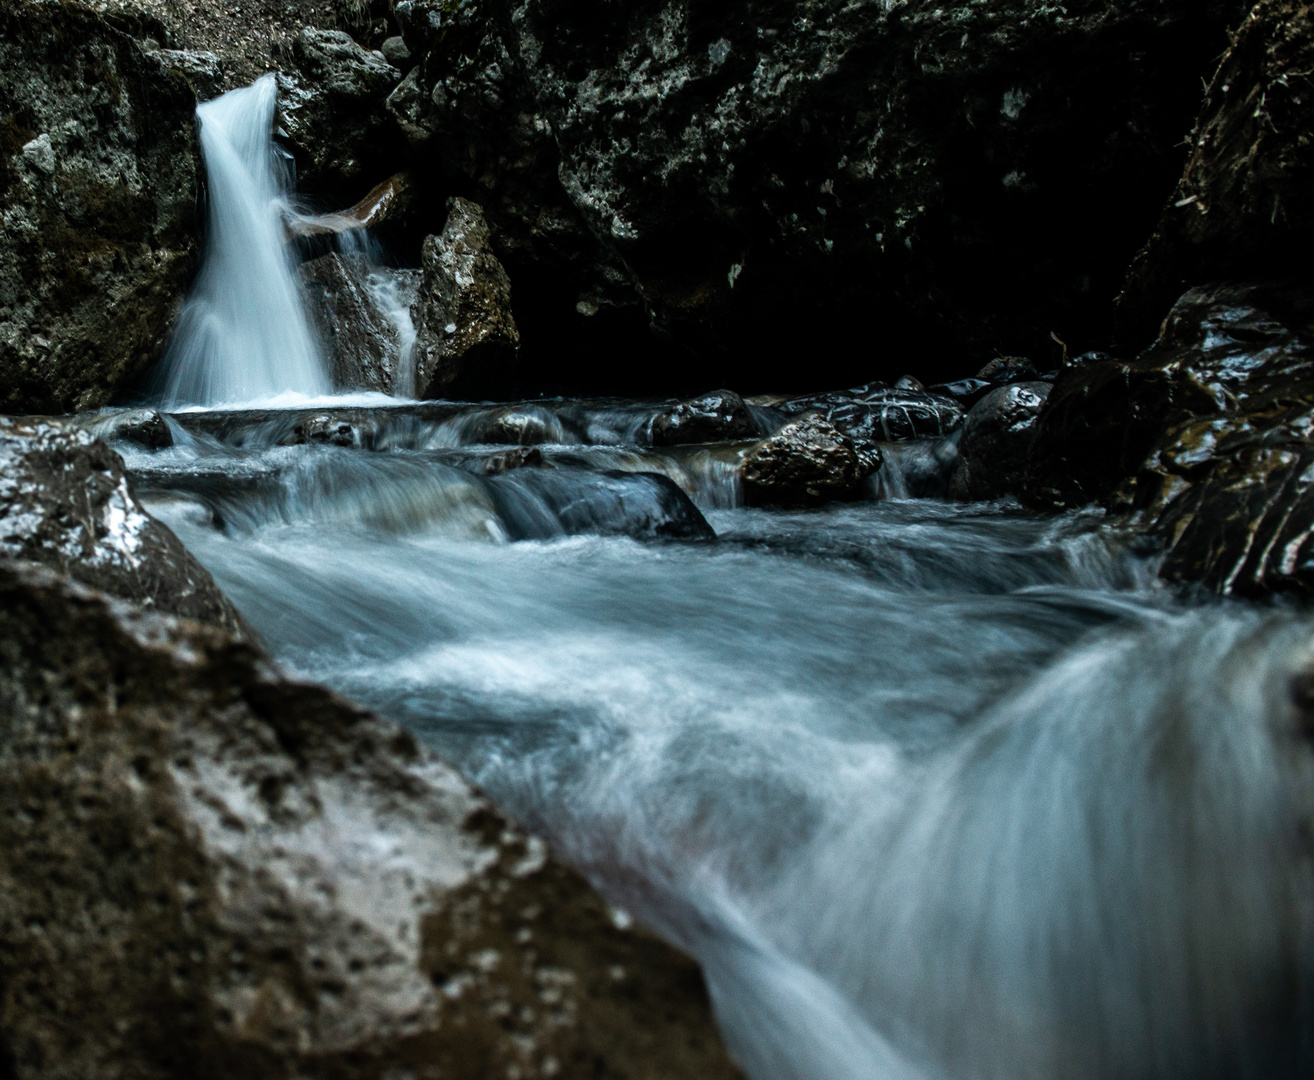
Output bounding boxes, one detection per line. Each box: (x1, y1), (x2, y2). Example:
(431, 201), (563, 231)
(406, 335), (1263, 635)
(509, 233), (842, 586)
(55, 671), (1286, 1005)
(159, 75), (331, 407)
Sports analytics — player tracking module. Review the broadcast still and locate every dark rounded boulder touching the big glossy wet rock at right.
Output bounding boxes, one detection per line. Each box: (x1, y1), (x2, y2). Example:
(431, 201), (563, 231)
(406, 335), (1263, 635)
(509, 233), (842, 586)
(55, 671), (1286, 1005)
(949, 382), (1051, 501)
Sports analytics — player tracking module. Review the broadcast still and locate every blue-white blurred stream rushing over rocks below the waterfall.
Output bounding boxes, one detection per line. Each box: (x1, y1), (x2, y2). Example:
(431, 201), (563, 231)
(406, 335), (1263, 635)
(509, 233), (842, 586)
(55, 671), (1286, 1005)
(122, 84), (1314, 1080)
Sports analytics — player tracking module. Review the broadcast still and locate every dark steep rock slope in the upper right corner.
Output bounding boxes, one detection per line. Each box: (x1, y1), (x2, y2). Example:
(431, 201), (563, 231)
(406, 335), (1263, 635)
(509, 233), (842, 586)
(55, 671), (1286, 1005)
(1118, 0), (1314, 348)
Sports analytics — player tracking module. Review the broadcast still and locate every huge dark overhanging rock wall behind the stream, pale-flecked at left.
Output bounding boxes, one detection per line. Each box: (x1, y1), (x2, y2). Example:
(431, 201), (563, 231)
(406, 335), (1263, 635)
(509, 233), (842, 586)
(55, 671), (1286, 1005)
(393, 0), (1244, 386)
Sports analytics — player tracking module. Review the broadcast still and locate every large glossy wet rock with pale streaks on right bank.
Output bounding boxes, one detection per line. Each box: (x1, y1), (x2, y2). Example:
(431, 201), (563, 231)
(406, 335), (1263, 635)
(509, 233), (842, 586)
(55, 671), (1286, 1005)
(1028, 285), (1314, 595)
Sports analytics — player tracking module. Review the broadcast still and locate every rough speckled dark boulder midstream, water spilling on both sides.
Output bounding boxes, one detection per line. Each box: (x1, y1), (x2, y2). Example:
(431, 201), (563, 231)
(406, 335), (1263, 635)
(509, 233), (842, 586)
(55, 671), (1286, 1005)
(740, 415), (880, 506)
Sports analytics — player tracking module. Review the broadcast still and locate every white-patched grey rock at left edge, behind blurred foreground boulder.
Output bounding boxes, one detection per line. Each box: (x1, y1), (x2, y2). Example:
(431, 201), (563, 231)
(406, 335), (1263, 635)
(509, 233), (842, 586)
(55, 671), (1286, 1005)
(0, 416), (248, 635)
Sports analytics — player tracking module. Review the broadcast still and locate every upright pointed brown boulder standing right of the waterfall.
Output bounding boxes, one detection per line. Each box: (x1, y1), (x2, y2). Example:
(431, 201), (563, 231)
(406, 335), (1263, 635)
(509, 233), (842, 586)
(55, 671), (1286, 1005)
(411, 198), (520, 398)
